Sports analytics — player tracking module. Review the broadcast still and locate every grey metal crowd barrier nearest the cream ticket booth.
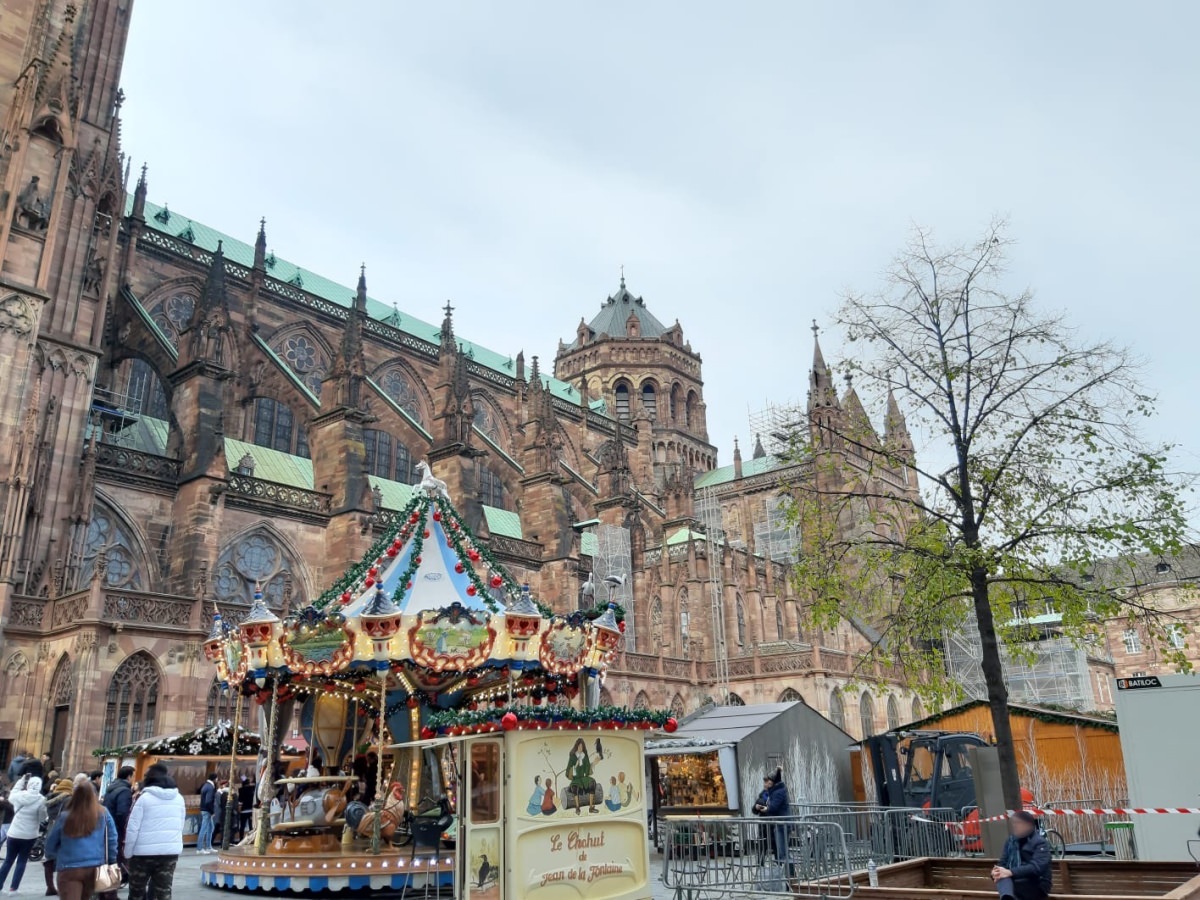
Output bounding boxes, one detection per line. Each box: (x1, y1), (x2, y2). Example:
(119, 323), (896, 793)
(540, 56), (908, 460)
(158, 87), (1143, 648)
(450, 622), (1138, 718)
(662, 816), (854, 900)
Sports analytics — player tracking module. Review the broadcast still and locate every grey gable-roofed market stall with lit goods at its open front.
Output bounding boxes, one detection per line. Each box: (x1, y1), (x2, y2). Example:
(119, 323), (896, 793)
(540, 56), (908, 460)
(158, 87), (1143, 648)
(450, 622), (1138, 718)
(646, 702), (854, 844)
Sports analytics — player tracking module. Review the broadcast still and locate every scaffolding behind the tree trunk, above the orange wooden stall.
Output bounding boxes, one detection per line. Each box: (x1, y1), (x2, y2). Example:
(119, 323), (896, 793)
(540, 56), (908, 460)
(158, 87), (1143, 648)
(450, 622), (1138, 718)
(946, 611), (1096, 710)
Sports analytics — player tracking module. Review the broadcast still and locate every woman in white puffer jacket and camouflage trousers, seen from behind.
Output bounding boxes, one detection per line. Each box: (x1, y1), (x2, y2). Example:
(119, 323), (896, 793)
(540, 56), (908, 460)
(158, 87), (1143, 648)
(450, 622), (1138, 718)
(125, 762), (187, 900)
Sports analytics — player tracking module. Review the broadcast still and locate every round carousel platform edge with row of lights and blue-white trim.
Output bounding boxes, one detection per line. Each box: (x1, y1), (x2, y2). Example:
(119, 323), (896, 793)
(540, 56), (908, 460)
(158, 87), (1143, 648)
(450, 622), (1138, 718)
(200, 847), (455, 893)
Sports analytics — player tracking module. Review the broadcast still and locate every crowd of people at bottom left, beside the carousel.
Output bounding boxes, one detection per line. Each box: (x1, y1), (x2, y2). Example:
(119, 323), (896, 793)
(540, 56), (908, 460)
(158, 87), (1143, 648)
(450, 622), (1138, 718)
(0, 754), (187, 900)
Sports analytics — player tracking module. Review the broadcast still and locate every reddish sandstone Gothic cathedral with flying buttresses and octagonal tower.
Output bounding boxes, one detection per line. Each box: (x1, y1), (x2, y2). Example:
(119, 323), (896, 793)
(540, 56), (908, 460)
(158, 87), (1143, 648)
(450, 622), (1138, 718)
(0, 0), (922, 769)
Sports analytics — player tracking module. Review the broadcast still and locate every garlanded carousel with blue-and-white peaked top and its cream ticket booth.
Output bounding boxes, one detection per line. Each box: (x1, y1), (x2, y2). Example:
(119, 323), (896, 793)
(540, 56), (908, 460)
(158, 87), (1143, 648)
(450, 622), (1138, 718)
(202, 467), (676, 900)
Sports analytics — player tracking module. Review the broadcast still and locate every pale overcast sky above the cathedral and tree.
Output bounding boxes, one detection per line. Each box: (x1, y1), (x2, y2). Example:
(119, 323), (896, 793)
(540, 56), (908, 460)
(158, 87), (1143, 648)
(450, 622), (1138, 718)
(122, 0), (1200, 489)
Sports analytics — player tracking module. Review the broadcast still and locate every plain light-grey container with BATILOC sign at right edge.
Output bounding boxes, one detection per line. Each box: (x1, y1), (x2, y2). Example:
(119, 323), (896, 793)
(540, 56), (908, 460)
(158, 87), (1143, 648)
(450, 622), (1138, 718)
(1115, 674), (1200, 860)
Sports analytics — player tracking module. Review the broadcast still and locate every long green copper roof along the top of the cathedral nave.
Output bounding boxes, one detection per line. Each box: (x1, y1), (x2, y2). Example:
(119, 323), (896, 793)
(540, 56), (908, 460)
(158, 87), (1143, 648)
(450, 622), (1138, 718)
(125, 193), (604, 412)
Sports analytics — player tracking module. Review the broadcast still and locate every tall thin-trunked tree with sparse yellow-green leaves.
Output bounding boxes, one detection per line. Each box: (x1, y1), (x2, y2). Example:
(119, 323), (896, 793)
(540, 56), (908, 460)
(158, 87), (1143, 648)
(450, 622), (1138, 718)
(793, 222), (1186, 809)
